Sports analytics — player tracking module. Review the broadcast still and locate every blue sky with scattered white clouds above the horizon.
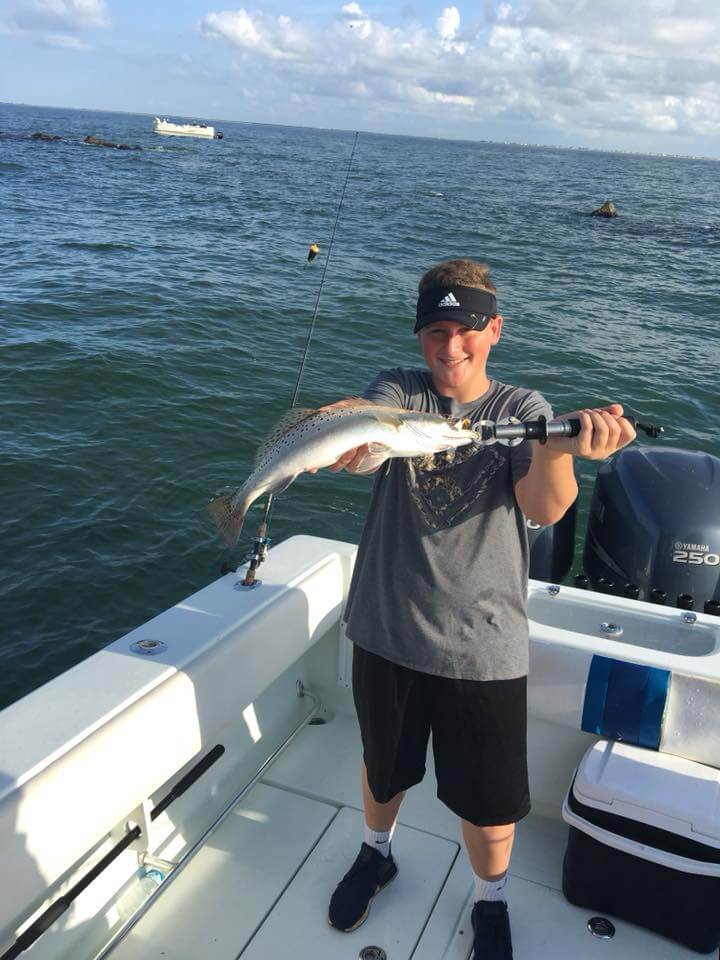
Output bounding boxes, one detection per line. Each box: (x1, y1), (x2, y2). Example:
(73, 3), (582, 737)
(0, 0), (720, 158)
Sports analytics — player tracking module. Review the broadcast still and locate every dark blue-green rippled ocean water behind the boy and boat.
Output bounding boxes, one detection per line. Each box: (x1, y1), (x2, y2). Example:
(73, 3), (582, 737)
(0, 105), (720, 706)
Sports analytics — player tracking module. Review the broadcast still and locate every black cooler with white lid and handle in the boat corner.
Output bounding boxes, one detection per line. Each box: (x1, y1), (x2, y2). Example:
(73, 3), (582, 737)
(563, 740), (720, 953)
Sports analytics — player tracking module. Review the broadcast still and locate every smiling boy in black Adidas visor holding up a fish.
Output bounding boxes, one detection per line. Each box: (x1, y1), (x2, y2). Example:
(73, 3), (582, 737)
(329, 260), (635, 960)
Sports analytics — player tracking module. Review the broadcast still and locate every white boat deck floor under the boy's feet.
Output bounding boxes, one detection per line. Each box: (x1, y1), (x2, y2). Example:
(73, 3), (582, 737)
(107, 713), (695, 960)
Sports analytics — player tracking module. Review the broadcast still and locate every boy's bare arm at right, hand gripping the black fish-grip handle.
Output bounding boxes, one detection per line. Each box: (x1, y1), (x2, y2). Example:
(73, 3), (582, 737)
(515, 403), (635, 526)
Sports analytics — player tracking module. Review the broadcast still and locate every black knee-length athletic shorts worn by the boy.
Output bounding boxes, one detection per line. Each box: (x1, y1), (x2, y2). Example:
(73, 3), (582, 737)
(353, 646), (530, 827)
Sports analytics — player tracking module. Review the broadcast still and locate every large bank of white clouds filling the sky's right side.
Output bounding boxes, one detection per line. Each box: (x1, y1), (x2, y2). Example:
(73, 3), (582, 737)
(198, 0), (720, 147)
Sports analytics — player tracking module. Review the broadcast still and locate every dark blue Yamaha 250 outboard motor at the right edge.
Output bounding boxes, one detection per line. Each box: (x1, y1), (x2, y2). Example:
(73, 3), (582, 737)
(584, 445), (720, 614)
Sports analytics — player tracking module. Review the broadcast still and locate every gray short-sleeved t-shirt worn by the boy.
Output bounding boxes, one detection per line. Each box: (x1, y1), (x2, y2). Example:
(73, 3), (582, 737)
(345, 368), (552, 680)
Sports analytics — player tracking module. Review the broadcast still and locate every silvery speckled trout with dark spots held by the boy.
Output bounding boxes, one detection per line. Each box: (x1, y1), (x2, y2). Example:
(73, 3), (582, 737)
(208, 400), (480, 547)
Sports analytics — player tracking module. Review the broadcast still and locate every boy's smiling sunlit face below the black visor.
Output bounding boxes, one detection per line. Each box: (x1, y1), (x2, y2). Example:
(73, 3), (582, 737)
(418, 315), (502, 401)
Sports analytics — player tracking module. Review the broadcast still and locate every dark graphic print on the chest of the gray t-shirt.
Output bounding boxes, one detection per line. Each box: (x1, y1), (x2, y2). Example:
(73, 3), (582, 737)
(406, 445), (508, 530)
